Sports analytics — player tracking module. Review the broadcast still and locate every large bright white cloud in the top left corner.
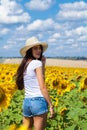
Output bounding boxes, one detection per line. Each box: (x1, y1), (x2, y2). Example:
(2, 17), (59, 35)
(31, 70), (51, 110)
(0, 0), (30, 24)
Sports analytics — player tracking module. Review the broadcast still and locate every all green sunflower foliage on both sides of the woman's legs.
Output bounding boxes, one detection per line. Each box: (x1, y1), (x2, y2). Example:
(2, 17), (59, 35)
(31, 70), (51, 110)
(0, 84), (87, 130)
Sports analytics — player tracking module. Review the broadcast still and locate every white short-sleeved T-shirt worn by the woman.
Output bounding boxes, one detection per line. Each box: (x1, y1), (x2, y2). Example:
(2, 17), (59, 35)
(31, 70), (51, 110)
(23, 60), (43, 98)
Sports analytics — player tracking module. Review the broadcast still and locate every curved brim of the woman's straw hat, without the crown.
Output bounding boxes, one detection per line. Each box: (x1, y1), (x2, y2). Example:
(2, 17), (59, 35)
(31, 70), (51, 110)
(20, 42), (48, 57)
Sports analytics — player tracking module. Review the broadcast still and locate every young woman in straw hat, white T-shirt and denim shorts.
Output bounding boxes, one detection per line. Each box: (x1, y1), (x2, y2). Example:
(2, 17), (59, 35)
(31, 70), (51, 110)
(16, 37), (54, 130)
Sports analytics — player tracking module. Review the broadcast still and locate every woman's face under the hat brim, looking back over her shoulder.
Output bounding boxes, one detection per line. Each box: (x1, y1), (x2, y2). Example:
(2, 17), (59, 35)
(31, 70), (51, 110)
(32, 45), (42, 59)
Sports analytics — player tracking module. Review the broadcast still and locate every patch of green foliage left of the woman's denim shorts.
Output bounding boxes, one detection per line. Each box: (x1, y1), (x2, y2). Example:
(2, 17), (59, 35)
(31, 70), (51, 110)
(0, 90), (24, 130)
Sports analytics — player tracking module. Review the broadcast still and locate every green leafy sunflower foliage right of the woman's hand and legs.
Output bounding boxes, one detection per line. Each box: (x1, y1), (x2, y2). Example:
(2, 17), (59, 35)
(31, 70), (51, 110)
(46, 81), (87, 130)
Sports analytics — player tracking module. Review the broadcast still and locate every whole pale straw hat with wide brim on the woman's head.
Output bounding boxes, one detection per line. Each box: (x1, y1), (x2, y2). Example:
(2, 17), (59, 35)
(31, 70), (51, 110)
(20, 37), (48, 56)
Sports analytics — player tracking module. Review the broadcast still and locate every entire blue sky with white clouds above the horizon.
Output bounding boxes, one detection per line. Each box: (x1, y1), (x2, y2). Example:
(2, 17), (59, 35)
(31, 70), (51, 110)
(0, 0), (87, 57)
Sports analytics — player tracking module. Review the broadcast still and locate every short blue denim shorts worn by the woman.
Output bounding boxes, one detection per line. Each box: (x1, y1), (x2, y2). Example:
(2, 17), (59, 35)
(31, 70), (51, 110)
(23, 97), (48, 117)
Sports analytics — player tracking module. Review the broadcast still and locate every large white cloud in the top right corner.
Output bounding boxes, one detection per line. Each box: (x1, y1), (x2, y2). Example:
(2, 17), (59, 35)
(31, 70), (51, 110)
(57, 1), (87, 21)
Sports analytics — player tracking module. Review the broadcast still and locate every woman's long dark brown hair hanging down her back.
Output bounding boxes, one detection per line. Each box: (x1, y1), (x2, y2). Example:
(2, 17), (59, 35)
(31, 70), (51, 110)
(16, 45), (43, 90)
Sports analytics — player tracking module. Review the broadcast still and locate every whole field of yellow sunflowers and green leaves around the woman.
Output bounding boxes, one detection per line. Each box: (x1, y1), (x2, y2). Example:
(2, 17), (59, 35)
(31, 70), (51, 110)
(0, 64), (87, 130)
